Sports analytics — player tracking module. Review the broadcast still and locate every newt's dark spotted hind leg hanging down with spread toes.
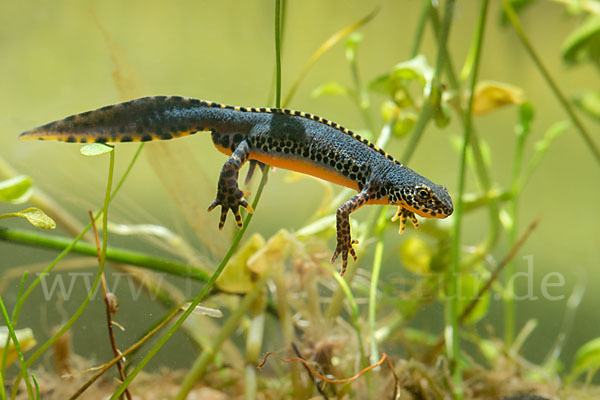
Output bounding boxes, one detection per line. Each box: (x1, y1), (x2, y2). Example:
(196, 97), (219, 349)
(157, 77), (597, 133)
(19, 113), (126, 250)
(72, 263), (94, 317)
(208, 140), (254, 229)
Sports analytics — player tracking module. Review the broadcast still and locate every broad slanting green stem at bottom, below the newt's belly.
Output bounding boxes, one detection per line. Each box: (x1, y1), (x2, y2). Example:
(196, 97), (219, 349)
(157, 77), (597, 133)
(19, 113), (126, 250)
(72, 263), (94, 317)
(175, 272), (270, 400)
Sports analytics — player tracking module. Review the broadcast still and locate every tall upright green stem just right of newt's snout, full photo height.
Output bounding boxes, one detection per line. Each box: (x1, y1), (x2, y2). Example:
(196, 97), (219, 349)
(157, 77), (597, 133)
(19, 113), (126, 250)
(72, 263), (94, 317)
(444, 0), (488, 399)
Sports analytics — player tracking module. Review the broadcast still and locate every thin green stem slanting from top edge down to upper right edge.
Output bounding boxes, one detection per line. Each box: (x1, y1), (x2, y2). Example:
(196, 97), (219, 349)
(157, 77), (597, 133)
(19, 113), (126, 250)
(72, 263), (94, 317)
(502, 0), (600, 163)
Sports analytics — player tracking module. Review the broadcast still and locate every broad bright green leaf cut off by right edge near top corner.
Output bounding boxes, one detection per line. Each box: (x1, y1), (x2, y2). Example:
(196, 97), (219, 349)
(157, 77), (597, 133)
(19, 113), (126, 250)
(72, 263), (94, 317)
(562, 15), (600, 66)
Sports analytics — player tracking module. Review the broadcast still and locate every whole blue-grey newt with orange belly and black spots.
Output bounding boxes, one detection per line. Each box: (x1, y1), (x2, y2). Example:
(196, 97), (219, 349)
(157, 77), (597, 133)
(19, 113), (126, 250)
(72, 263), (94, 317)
(19, 96), (453, 275)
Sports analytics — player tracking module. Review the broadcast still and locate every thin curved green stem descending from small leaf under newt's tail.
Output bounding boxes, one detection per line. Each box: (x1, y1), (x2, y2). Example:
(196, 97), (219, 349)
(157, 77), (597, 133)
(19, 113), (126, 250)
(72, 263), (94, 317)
(12, 149), (115, 399)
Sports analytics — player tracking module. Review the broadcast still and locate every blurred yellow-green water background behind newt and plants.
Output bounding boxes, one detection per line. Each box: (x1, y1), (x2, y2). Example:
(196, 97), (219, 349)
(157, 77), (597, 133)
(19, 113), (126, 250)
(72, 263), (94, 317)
(0, 0), (600, 374)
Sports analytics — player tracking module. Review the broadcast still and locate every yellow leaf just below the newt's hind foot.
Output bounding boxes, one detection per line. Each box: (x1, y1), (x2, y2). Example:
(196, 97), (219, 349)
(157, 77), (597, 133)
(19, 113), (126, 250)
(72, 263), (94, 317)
(215, 233), (266, 293)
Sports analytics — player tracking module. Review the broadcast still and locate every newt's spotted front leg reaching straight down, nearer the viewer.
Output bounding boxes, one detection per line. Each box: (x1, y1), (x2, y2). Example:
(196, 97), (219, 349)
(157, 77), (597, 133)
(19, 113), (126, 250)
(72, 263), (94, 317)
(331, 190), (369, 275)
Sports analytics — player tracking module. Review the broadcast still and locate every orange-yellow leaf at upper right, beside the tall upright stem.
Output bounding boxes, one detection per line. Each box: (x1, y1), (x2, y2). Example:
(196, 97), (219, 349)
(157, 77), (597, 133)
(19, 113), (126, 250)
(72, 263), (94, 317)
(473, 81), (525, 115)
